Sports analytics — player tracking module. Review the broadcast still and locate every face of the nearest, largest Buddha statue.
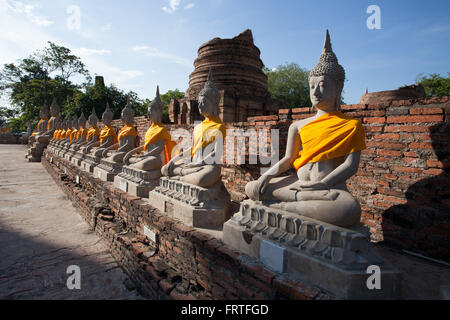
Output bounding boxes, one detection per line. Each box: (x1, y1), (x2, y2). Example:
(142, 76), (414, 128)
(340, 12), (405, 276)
(309, 75), (342, 112)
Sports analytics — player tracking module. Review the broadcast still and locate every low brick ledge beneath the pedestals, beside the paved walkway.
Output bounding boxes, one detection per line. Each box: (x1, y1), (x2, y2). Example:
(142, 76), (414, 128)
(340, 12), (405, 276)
(42, 151), (334, 299)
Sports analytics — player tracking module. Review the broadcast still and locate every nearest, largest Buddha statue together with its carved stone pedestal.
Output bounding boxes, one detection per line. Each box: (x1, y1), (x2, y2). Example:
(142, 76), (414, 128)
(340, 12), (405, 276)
(223, 30), (399, 298)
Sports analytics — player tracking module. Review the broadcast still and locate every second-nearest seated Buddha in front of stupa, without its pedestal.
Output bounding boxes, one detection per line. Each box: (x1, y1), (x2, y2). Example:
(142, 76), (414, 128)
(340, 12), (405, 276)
(161, 70), (226, 188)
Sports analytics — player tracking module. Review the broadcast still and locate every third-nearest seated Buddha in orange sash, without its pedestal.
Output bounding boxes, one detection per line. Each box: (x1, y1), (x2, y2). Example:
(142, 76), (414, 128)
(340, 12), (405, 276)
(123, 87), (176, 171)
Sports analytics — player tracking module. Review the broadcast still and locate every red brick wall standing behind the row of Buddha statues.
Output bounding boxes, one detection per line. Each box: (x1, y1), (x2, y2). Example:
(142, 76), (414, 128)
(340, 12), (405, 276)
(110, 97), (450, 261)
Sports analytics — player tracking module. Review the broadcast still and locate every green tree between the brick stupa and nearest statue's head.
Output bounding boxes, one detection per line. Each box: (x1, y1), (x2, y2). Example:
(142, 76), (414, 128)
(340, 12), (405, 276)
(263, 62), (311, 108)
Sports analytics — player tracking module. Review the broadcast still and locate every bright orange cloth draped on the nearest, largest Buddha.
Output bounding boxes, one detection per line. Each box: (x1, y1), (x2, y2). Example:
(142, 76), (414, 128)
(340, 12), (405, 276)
(294, 111), (366, 170)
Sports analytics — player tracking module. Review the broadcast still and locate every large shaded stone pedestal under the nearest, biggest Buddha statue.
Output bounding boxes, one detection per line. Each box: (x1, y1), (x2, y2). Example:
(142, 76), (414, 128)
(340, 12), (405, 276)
(223, 200), (401, 299)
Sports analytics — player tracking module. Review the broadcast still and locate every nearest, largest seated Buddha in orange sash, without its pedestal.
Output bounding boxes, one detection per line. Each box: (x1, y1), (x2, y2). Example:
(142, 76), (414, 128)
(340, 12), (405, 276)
(245, 30), (365, 227)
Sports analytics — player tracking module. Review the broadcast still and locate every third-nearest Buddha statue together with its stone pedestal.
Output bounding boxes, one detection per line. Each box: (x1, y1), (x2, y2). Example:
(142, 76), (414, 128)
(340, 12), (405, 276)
(114, 87), (176, 198)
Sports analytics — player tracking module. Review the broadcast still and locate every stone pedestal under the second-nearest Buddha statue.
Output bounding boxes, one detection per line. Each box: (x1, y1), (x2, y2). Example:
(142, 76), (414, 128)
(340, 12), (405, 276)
(149, 177), (231, 230)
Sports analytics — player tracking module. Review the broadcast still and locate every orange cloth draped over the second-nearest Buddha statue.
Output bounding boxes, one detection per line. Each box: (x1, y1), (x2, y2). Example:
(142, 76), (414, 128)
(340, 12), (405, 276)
(191, 116), (227, 156)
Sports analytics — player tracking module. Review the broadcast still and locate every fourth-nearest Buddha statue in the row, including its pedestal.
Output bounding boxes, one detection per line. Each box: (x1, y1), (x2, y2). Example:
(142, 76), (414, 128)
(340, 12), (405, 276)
(94, 98), (137, 181)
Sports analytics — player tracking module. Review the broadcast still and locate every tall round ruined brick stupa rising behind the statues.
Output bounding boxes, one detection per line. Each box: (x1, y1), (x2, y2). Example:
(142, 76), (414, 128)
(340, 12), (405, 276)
(169, 30), (279, 124)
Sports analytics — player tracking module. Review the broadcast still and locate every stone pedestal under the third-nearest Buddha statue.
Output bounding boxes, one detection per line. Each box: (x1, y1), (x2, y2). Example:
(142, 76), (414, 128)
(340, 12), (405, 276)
(114, 166), (161, 198)
